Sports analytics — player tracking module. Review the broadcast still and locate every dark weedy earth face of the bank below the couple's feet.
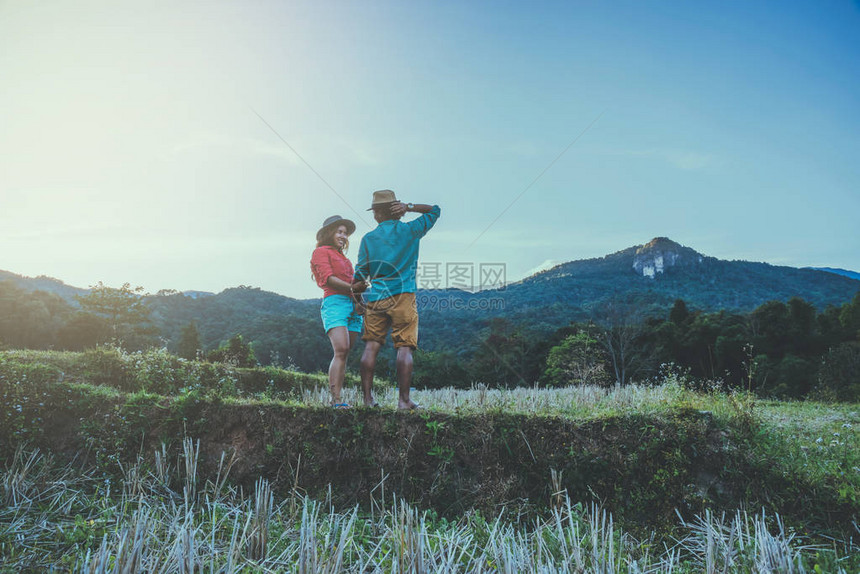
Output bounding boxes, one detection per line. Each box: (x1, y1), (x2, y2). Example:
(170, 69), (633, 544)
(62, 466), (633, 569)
(5, 385), (838, 525)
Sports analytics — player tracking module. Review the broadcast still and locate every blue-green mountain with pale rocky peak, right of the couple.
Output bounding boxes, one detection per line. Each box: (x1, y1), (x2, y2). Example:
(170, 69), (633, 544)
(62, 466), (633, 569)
(419, 237), (860, 349)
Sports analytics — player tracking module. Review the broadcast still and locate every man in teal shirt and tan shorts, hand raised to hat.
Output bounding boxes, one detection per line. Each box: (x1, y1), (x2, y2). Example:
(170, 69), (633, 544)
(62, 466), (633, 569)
(355, 189), (441, 409)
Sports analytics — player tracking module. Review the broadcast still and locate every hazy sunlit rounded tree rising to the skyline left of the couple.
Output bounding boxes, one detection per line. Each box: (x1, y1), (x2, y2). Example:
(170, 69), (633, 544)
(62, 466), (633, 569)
(77, 281), (154, 348)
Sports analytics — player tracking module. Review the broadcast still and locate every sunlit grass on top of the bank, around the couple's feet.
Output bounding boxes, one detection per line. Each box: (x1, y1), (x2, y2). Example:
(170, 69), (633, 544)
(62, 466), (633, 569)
(0, 348), (860, 504)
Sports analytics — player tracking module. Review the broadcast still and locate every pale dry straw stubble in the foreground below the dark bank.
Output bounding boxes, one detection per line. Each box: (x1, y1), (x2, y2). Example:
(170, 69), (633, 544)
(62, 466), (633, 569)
(0, 450), (860, 573)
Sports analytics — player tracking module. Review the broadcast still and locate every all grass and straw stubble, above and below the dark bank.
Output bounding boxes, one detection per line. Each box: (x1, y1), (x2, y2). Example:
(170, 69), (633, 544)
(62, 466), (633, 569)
(0, 349), (860, 572)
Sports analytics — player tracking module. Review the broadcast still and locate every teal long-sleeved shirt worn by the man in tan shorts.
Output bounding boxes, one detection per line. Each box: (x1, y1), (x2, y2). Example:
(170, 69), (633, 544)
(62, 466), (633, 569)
(355, 205), (442, 301)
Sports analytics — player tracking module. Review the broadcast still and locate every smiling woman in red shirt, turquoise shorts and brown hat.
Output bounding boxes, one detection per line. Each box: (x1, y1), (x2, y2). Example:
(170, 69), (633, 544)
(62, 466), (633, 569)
(311, 215), (367, 409)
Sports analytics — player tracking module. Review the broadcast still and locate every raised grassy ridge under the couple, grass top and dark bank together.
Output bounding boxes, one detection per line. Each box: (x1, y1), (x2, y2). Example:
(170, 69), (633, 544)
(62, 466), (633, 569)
(0, 350), (860, 572)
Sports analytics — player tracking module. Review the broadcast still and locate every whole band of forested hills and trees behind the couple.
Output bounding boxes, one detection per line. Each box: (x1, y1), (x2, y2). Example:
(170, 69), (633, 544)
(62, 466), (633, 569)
(0, 238), (860, 398)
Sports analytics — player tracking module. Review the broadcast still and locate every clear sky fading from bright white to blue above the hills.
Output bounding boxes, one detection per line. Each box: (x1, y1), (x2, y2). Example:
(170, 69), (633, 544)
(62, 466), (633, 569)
(0, 0), (860, 299)
